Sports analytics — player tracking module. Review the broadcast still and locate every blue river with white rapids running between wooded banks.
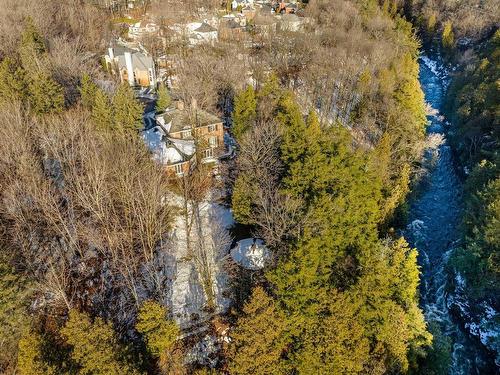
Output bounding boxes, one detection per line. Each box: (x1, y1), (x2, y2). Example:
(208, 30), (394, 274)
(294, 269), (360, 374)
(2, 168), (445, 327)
(405, 58), (496, 375)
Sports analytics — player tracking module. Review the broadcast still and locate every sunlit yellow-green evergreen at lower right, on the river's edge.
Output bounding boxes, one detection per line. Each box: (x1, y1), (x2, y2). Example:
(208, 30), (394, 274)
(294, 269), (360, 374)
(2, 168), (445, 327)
(349, 240), (432, 373)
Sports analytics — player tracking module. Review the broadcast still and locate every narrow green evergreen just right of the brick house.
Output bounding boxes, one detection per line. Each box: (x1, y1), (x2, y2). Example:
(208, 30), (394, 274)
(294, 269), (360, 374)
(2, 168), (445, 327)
(233, 85), (257, 141)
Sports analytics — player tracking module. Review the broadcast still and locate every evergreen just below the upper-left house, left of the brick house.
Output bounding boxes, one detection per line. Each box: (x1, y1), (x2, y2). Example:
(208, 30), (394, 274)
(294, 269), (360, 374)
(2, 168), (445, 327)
(113, 83), (144, 133)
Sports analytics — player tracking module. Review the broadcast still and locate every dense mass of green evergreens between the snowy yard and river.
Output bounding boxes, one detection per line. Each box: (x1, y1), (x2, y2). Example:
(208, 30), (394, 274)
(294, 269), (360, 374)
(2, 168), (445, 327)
(229, 86), (431, 374)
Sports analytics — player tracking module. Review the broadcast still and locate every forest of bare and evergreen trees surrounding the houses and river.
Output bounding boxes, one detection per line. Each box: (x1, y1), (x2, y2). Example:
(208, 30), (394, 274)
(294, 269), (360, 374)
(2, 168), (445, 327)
(0, 0), (500, 375)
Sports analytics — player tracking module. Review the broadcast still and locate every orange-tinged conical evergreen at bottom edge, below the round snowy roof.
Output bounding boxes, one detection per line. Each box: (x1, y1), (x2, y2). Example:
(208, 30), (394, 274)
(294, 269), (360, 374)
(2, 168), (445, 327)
(228, 286), (288, 375)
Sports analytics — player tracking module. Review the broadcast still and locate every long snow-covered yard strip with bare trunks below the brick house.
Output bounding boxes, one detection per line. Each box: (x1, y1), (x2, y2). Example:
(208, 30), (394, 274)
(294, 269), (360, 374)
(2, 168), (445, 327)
(161, 196), (234, 330)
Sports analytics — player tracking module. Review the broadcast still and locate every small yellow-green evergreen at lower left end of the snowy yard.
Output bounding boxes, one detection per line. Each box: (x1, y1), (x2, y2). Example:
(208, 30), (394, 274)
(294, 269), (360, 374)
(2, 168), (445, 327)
(136, 301), (180, 357)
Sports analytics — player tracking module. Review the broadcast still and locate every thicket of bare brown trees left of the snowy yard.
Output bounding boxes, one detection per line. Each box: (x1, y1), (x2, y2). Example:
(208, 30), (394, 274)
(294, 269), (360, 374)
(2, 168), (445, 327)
(0, 105), (171, 324)
